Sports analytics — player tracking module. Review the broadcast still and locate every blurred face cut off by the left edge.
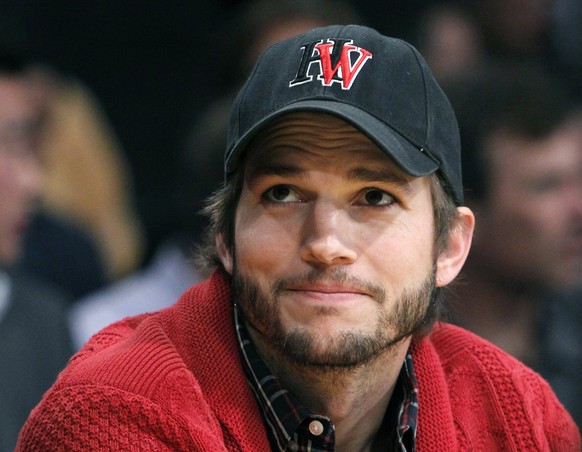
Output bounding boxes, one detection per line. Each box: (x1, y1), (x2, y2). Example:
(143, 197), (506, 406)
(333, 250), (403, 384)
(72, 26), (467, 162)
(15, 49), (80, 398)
(0, 76), (41, 265)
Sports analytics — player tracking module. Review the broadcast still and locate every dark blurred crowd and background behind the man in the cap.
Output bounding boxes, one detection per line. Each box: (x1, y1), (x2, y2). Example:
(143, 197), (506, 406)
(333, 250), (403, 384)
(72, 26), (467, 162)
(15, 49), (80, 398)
(0, 0), (582, 451)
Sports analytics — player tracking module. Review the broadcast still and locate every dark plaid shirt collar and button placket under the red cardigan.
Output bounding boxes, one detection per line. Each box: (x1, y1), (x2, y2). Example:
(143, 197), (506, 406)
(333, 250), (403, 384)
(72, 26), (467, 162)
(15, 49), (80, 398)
(234, 304), (418, 452)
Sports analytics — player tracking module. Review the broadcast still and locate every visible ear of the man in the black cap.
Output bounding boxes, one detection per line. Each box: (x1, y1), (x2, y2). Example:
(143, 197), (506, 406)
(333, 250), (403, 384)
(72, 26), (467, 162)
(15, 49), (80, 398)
(436, 207), (475, 287)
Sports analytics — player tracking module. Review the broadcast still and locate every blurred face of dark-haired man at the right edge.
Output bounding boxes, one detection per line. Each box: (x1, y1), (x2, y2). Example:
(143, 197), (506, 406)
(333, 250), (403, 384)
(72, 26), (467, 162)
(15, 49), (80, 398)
(475, 124), (582, 287)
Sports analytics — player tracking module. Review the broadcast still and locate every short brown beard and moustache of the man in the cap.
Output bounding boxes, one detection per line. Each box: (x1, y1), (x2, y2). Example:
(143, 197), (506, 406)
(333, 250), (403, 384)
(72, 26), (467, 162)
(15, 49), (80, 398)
(233, 266), (436, 370)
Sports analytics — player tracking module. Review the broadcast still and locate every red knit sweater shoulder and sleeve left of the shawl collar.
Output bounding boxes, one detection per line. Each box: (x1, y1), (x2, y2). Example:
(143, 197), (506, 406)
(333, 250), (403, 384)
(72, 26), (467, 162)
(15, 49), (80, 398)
(18, 298), (234, 450)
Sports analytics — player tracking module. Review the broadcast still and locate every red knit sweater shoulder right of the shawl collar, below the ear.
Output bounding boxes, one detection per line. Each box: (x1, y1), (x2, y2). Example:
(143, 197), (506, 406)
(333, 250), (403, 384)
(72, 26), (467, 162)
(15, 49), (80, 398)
(413, 323), (580, 450)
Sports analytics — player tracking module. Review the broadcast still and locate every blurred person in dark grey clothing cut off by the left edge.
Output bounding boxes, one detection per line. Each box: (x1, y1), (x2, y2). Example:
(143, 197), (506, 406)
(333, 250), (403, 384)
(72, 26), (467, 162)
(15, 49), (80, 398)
(0, 51), (72, 451)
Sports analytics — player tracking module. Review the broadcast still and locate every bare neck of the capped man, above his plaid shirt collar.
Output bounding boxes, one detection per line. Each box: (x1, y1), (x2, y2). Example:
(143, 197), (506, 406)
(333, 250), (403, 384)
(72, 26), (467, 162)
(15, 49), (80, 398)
(250, 331), (410, 451)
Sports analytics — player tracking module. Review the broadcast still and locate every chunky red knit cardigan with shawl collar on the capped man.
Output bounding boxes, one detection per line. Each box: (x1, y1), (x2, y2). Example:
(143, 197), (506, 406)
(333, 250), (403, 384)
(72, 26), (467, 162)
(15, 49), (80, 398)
(17, 274), (580, 452)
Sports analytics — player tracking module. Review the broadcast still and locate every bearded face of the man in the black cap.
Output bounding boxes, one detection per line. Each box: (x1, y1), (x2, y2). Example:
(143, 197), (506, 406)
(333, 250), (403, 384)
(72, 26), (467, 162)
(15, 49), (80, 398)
(222, 113), (456, 367)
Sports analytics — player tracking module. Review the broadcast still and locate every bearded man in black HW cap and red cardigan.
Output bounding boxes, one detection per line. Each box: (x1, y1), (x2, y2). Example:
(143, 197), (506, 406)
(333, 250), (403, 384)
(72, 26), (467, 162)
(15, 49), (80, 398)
(19, 26), (580, 451)
